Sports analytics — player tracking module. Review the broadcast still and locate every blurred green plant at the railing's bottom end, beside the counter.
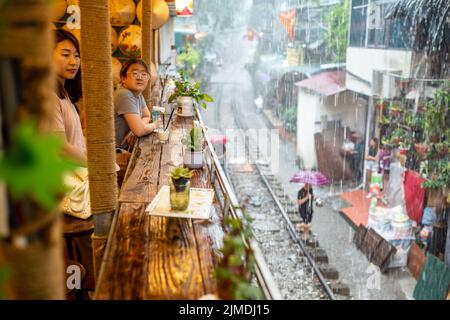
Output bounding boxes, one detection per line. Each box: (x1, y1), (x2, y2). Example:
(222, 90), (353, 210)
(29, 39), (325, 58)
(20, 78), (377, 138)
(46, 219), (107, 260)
(215, 214), (263, 300)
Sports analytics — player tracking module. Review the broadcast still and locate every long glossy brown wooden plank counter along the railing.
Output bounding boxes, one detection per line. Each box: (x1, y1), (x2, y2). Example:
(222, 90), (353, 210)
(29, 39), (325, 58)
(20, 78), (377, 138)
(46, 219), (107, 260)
(95, 117), (223, 299)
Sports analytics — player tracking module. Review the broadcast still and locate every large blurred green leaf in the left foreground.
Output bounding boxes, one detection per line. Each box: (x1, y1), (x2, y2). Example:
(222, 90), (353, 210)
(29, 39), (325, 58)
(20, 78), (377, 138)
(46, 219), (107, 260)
(0, 122), (76, 210)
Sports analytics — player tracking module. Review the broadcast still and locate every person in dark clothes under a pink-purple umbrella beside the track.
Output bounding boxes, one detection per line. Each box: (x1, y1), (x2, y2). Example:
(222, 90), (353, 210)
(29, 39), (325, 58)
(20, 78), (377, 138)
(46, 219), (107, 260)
(290, 171), (330, 241)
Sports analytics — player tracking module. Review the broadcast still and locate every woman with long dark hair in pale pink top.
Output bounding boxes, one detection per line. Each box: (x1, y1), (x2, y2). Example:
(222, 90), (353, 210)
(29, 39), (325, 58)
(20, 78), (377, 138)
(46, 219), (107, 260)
(52, 30), (87, 166)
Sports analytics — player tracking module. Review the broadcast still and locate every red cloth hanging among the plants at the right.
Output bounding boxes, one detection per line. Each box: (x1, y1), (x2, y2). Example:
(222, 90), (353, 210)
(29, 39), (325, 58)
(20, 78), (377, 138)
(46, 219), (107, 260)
(403, 170), (426, 224)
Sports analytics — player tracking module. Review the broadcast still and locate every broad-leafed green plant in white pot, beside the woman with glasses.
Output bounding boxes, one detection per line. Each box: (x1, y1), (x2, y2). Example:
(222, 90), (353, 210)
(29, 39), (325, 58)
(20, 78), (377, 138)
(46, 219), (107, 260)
(169, 74), (214, 116)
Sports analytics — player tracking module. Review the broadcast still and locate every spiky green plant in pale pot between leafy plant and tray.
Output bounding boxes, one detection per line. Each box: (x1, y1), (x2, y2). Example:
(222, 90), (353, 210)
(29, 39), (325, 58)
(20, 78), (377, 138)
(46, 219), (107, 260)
(181, 127), (204, 169)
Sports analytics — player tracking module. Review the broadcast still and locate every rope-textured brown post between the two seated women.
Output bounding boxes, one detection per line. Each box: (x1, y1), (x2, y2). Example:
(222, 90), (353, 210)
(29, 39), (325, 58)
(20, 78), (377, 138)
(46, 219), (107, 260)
(80, 0), (117, 278)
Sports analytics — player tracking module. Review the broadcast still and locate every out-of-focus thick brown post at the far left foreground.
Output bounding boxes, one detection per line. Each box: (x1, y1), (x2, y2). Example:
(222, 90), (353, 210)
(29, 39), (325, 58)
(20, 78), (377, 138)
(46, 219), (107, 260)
(0, 0), (65, 299)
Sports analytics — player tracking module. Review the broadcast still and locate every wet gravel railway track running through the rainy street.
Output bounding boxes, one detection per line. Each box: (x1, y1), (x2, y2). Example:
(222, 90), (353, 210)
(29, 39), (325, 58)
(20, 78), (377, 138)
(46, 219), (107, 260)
(226, 102), (350, 300)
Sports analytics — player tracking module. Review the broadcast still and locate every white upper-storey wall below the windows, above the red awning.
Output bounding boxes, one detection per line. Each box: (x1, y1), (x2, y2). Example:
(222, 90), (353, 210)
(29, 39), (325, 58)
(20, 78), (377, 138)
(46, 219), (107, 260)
(346, 47), (412, 96)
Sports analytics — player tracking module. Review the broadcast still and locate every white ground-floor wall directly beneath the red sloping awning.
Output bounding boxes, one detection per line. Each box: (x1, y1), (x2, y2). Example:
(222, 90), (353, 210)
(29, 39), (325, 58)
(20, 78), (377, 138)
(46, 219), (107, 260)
(297, 88), (367, 168)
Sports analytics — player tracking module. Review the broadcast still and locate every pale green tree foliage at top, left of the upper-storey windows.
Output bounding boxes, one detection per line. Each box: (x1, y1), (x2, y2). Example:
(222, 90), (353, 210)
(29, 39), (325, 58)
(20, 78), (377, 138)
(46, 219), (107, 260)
(325, 0), (350, 62)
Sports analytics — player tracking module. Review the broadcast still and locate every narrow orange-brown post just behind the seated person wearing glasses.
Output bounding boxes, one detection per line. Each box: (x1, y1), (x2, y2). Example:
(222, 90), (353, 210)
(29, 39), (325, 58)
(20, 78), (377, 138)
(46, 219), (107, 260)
(142, 0), (153, 106)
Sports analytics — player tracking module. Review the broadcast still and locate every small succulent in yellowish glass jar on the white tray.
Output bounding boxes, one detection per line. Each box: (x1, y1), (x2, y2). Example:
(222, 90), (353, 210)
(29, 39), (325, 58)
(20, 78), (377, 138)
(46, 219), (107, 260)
(170, 168), (194, 211)
